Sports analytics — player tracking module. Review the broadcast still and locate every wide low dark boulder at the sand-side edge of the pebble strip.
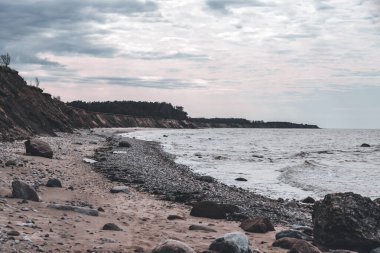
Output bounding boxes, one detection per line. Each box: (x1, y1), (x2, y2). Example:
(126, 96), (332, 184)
(190, 201), (227, 219)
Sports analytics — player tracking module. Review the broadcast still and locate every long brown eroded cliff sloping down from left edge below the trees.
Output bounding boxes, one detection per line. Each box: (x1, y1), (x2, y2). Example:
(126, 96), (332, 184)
(0, 67), (195, 140)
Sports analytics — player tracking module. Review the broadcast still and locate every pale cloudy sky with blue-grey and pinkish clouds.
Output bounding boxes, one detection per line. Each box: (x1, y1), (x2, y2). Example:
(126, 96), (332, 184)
(0, 0), (380, 128)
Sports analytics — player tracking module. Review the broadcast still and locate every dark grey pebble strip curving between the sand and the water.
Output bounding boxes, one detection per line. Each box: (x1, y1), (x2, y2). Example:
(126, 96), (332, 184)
(94, 132), (312, 225)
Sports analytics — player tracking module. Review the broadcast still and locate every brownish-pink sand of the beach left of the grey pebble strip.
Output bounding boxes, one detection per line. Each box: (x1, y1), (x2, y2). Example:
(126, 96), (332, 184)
(0, 129), (286, 252)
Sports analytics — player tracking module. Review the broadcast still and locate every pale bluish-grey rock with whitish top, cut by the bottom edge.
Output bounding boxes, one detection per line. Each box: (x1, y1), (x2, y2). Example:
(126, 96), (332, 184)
(209, 232), (252, 253)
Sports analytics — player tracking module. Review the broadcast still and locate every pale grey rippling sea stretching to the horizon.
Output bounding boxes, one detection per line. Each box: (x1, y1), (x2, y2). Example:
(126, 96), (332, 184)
(123, 128), (380, 200)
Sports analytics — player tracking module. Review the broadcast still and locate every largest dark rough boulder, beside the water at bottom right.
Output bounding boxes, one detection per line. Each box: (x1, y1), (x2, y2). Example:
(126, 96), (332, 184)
(313, 192), (380, 250)
